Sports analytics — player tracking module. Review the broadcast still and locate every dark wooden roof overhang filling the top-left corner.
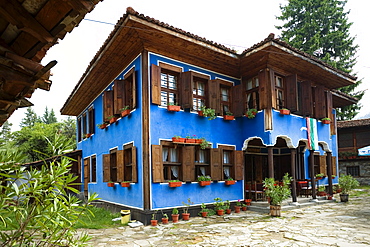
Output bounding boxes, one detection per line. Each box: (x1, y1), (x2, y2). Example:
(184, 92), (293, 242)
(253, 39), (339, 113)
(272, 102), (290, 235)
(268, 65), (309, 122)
(0, 0), (101, 126)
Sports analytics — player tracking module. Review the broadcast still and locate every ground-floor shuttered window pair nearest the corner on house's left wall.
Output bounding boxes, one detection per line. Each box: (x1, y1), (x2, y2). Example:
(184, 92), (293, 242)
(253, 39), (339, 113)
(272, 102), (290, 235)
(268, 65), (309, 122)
(103, 144), (137, 183)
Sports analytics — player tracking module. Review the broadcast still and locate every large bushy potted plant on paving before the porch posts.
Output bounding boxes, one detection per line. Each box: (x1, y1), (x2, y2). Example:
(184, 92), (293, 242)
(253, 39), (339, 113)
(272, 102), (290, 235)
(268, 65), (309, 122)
(263, 173), (291, 216)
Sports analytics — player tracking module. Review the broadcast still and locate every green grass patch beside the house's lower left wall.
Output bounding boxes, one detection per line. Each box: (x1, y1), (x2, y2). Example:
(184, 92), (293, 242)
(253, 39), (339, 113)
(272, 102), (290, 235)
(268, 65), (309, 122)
(74, 207), (122, 229)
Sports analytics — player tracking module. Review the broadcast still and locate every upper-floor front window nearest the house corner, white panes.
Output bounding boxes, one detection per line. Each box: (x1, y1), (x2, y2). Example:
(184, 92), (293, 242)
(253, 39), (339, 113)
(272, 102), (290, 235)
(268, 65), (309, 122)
(161, 69), (179, 106)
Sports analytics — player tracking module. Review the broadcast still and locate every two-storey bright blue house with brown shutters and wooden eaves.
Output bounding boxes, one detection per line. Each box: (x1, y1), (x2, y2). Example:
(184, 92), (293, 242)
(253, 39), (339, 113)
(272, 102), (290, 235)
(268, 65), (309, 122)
(61, 8), (356, 223)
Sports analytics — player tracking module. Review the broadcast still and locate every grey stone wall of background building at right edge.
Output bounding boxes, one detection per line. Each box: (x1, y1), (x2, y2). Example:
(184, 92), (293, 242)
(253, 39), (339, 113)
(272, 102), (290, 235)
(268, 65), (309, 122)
(339, 157), (370, 185)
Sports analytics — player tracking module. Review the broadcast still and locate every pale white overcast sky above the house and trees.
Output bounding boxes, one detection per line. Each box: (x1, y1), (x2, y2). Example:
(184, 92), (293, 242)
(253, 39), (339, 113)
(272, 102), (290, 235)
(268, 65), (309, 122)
(8, 0), (370, 131)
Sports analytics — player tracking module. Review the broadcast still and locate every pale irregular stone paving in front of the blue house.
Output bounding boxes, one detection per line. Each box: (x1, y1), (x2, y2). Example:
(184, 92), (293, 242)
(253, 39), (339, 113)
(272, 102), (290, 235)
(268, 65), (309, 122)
(81, 194), (370, 247)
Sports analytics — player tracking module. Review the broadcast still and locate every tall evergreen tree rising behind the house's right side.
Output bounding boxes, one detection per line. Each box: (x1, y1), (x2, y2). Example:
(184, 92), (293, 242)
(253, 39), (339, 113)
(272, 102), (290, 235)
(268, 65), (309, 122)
(276, 0), (364, 120)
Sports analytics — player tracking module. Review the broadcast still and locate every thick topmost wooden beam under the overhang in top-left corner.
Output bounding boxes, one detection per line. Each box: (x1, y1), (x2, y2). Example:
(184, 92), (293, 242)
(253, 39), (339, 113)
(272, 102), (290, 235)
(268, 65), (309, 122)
(0, 0), (54, 43)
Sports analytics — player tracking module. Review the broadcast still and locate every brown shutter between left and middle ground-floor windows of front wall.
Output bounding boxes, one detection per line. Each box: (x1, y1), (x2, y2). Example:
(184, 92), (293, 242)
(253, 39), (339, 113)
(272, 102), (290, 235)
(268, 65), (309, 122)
(181, 146), (195, 182)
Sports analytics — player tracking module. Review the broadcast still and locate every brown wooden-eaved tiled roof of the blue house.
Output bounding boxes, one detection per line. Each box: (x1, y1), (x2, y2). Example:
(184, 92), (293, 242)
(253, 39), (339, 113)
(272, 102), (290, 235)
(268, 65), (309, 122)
(61, 7), (357, 116)
